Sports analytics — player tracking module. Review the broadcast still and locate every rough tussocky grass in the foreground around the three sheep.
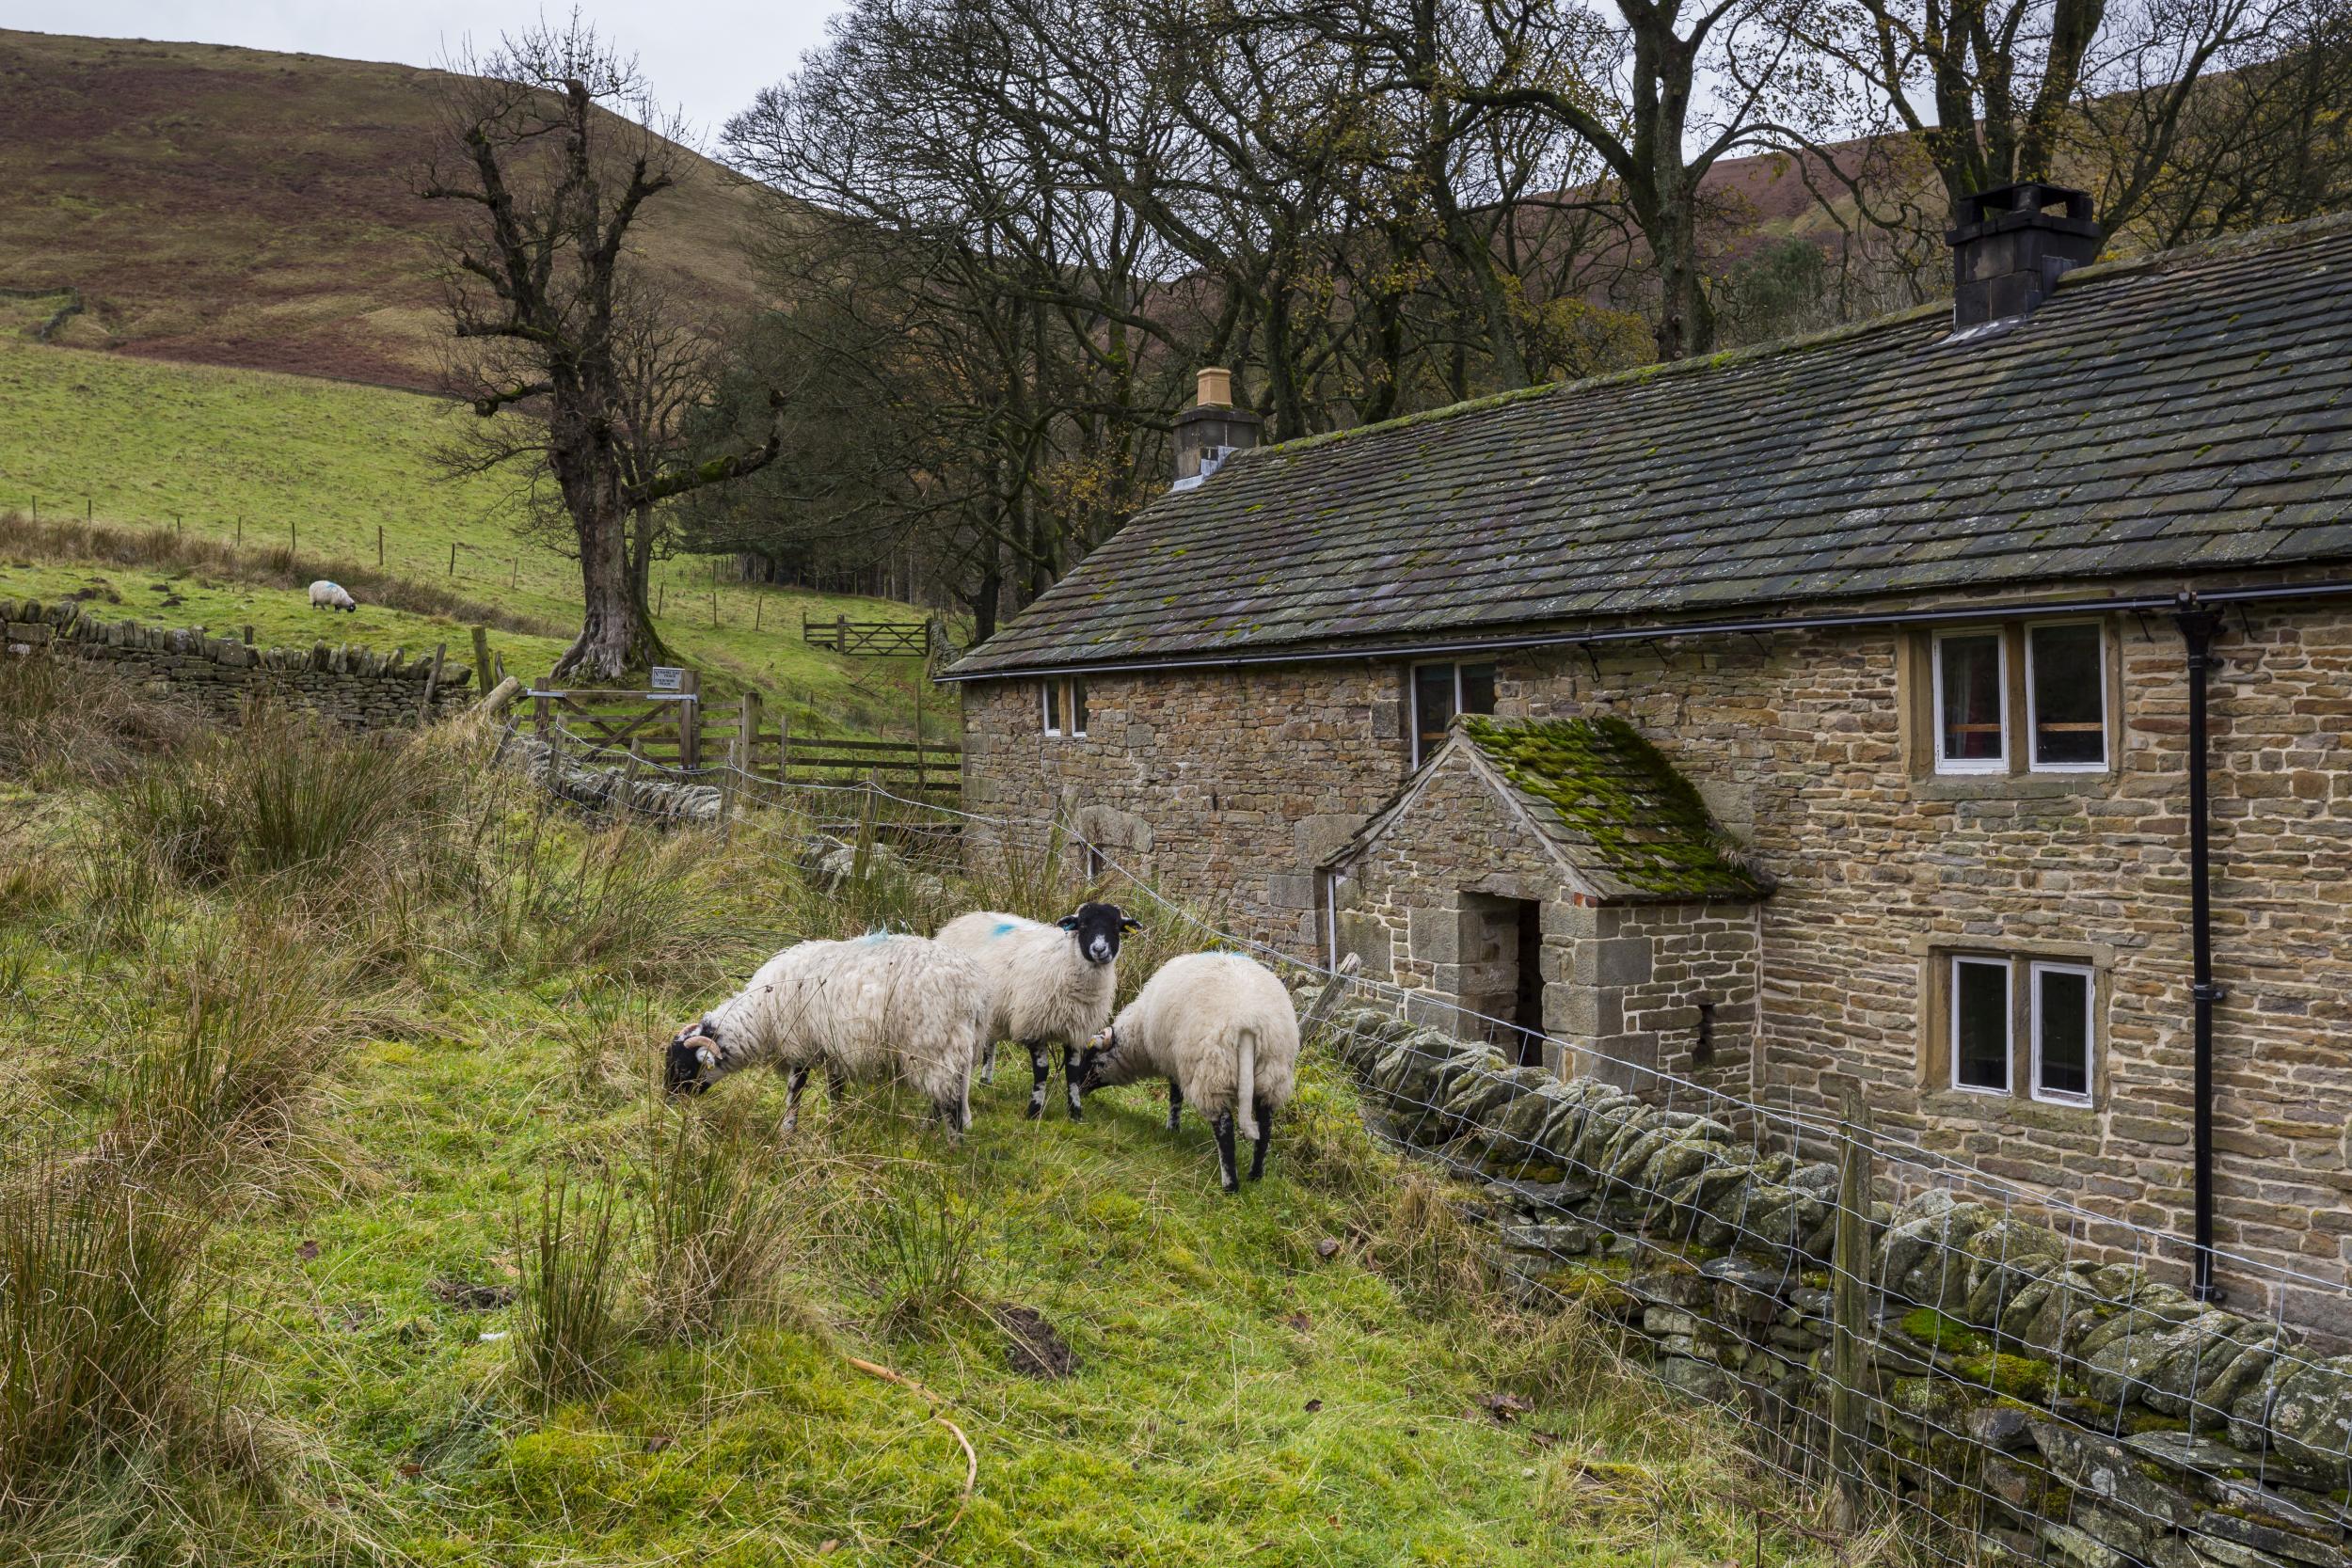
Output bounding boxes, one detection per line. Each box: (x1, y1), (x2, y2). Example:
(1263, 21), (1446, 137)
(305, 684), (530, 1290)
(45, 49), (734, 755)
(0, 663), (1853, 1568)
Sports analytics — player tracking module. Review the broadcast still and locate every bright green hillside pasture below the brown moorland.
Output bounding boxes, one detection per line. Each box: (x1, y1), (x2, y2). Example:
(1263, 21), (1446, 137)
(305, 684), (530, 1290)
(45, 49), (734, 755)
(0, 333), (953, 734)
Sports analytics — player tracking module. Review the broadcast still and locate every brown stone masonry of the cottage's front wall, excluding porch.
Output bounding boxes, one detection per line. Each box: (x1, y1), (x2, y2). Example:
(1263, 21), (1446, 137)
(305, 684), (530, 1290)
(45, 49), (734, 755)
(967, 607), (2352, 1333)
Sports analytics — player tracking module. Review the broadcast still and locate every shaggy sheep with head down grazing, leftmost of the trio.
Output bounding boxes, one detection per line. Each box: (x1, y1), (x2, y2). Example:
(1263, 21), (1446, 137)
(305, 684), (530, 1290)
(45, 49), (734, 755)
(668, 933), (988, 1133)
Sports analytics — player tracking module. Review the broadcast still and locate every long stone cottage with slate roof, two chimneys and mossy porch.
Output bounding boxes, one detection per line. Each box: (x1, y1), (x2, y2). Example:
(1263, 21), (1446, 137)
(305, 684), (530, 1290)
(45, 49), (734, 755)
(948, 185), (2352, 1312)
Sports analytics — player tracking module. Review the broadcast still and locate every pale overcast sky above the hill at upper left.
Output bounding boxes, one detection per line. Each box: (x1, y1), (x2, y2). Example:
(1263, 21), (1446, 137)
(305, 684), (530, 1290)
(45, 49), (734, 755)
(0, 0), (840, 138)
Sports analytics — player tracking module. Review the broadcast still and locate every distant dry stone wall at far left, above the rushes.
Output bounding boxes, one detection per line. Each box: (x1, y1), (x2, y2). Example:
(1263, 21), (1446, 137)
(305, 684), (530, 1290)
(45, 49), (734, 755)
(0, 599), (473, 729)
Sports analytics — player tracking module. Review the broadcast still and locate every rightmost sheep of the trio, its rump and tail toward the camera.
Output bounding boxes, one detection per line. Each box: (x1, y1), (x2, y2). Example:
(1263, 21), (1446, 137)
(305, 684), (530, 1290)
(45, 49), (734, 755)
(1077, 952), (1298, 1192)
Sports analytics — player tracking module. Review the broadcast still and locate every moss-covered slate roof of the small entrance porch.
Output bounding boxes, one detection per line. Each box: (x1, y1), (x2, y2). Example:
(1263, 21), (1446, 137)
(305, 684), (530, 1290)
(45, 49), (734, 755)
(1325, 717), (1772, 903)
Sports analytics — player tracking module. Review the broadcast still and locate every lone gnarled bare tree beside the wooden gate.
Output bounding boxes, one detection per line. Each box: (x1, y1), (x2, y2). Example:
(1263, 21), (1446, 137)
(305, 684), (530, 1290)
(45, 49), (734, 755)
(421, 14), (776, 679)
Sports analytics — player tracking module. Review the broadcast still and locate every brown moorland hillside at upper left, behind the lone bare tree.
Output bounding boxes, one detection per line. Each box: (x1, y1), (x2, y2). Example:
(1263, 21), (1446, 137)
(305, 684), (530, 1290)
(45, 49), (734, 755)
(0, 30), (753, 388)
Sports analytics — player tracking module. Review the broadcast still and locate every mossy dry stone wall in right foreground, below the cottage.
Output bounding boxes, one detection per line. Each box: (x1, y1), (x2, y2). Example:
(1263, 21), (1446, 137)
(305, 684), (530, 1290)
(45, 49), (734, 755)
(1303, 999), (2352, 1568)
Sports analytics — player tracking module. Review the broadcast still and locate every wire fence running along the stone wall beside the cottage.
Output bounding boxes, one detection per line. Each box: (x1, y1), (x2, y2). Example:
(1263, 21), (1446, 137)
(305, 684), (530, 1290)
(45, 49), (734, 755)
(515, 714), (2352, 1568)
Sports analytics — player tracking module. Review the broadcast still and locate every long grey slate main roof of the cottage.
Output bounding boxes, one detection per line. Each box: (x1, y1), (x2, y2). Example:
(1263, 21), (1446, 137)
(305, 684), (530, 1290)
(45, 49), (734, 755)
(950, 218), (2352, 677)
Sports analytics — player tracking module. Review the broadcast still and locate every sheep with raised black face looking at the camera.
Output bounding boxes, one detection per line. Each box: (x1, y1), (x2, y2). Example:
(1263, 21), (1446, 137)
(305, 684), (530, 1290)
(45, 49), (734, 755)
(939, 903), (1136, 1121)
